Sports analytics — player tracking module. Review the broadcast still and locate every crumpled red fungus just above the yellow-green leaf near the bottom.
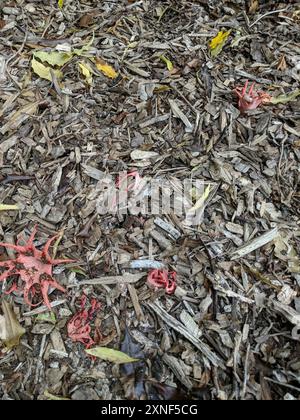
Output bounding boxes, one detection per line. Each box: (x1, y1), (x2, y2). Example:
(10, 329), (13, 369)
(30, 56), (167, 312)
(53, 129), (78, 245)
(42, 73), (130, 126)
(67, 295), (100, 349)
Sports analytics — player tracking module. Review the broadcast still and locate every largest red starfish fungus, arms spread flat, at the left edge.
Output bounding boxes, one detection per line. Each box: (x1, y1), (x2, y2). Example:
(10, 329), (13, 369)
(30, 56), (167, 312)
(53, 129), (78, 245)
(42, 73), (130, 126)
(0, 227), (73, 310)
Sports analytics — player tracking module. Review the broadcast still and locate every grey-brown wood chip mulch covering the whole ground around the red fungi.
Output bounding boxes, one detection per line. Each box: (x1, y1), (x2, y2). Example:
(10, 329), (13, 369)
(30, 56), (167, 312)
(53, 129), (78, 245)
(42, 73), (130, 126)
(0, 0), (300, 400)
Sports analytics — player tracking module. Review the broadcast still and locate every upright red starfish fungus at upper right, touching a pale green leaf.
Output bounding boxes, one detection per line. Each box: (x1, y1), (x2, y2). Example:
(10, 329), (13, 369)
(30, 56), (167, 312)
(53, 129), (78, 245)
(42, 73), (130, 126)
(234, 80), (271, 113)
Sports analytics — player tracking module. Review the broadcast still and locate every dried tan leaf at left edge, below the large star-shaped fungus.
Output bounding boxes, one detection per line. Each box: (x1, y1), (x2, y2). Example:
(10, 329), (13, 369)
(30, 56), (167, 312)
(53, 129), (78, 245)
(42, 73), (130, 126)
(0, 300), (26, 349)
